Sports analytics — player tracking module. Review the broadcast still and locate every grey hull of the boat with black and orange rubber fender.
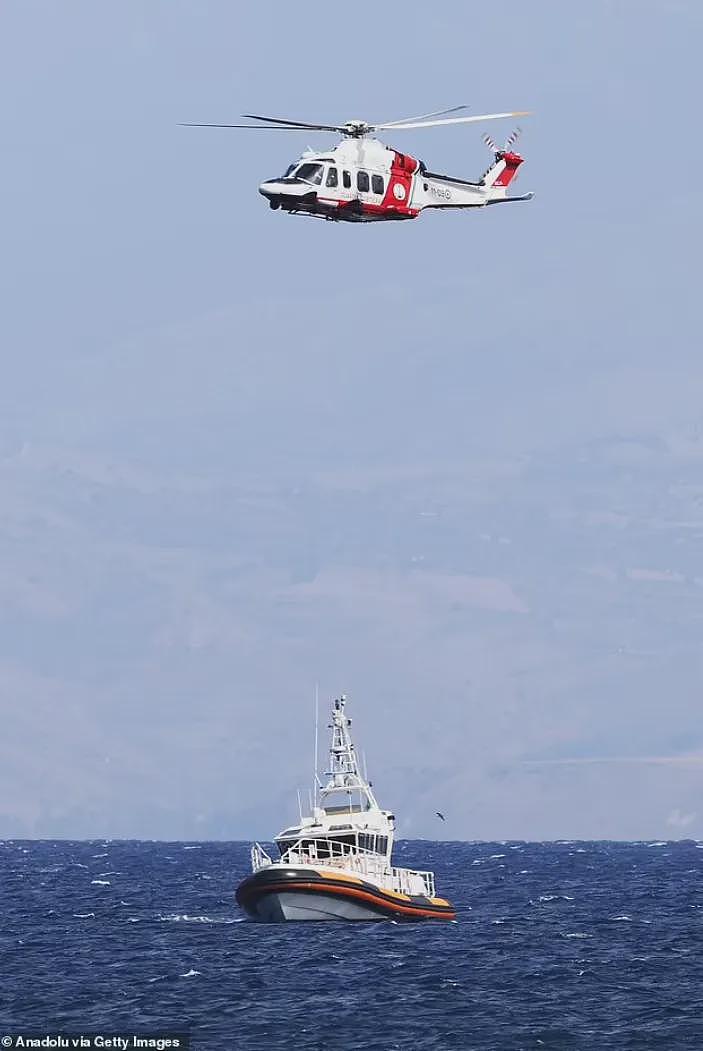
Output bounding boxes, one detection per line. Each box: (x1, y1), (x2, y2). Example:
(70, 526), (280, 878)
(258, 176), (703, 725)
(236, 865), (456, 923)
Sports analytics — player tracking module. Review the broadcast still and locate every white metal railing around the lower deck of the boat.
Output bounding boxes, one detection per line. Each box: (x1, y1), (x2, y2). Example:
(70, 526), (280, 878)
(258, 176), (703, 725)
(264, 837), (435, 898)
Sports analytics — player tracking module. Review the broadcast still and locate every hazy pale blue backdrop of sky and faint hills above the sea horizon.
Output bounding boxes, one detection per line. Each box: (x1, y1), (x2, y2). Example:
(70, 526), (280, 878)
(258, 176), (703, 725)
(0, 0), (703, 840)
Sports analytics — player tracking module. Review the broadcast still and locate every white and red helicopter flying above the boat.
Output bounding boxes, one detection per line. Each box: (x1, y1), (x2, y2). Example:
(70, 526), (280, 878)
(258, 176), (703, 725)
(182, 106), (533, 223)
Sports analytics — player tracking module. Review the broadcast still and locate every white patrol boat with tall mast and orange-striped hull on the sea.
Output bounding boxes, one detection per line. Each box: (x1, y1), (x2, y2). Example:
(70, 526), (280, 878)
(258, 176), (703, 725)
(236, 695), (456, 923)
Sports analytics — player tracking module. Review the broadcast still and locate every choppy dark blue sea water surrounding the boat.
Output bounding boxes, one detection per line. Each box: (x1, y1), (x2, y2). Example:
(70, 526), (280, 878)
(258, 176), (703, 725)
(0, 841), (703, 1051)
